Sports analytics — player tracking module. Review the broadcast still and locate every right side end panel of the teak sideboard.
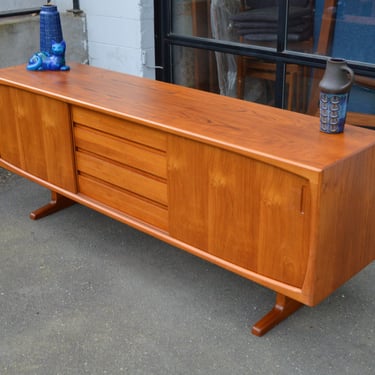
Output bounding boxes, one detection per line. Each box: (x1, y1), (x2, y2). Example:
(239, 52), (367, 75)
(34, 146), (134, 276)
(311, 147), (375, 304)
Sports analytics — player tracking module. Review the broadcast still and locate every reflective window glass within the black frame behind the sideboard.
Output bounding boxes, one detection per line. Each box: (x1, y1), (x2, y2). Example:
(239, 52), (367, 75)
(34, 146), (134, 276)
(171, 0), (375, 126)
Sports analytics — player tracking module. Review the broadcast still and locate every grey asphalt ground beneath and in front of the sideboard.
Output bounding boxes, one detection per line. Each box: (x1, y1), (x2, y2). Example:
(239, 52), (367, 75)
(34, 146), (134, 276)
(0, 169), (375, 375)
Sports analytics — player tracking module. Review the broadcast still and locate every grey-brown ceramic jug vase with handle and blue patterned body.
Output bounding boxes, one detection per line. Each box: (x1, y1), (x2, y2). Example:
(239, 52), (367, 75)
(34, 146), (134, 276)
(319, 59), (354, 133)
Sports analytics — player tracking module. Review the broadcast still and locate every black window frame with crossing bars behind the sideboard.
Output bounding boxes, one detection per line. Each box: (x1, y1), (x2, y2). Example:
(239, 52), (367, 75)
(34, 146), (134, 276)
(154, 0), (375, 108)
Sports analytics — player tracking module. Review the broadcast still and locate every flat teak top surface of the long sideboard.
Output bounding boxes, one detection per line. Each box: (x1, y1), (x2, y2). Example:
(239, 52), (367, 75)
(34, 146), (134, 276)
(0, 63), (375, 176)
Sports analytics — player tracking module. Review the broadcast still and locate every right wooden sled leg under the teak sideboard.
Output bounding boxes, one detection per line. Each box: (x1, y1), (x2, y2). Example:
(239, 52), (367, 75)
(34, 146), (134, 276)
(251, 293), (303, 336)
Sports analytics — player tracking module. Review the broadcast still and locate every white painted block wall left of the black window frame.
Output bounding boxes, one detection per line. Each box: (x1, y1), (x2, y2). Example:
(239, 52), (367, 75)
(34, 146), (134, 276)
(56, 0), (155, 78)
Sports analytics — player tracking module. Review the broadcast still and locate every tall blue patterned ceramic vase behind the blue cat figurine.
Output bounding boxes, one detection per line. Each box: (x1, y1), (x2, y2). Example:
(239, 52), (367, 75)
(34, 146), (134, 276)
(40, 4), (63, 53)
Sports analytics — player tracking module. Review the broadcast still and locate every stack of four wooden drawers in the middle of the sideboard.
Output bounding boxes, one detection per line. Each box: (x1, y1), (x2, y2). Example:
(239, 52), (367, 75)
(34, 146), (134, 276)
(72, 107), (168, 231)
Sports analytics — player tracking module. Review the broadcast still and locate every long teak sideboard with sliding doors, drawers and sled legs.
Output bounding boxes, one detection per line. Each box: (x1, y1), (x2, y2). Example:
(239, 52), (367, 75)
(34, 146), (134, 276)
(0, 64), (375, 336)
